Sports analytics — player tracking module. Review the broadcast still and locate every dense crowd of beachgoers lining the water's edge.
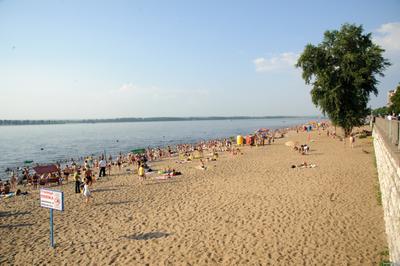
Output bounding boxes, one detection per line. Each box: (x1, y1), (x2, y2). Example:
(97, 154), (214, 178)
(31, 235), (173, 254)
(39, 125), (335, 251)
(0, 125), (310, 202)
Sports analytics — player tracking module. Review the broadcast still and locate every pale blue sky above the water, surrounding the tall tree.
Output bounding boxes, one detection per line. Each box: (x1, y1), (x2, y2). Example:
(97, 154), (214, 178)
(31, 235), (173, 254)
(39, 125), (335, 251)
(0, 0), (400, 119)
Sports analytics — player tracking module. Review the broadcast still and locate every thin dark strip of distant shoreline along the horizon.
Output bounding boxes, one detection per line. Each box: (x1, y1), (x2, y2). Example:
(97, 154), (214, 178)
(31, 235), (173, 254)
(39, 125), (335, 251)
(0, 116), (319, 126)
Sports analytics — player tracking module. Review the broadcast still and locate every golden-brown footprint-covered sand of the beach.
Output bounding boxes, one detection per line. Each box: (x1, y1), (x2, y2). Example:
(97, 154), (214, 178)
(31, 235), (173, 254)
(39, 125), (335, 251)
(0, 129), (387, 265)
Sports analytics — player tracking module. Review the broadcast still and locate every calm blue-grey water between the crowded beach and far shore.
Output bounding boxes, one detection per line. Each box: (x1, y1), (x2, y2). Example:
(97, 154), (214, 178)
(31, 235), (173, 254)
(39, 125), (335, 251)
(0, 118), (316, 178)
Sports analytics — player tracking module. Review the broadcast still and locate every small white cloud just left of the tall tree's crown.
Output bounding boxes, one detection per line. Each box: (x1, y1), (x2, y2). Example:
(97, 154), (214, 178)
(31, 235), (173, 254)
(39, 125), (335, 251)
(253, 52), (299, 72)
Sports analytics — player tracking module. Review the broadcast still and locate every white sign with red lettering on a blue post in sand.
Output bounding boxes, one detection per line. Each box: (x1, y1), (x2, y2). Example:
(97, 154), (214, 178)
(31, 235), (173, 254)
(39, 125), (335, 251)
(40, 188), (64, 248)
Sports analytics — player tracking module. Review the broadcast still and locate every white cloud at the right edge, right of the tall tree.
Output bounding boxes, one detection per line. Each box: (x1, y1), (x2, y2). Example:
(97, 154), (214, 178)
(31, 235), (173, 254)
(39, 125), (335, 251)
(373, 22), (400, 53)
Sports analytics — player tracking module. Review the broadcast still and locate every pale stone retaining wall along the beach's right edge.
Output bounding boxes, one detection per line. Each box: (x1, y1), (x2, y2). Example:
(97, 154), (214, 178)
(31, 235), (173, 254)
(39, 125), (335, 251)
(373, 127), (400, 266)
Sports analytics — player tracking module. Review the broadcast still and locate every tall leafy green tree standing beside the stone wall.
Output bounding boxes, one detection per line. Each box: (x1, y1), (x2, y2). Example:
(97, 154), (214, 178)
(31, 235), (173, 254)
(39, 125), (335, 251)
(296, 24), (390, 136)
